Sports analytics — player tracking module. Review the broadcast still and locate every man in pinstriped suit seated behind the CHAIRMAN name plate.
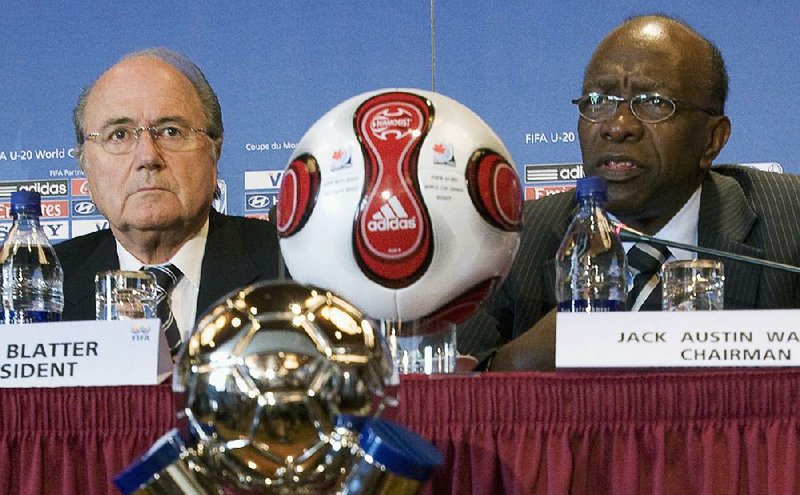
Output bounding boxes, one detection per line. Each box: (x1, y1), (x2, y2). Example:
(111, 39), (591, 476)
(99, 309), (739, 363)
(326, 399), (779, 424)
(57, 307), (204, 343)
(459, 16), (800, 370)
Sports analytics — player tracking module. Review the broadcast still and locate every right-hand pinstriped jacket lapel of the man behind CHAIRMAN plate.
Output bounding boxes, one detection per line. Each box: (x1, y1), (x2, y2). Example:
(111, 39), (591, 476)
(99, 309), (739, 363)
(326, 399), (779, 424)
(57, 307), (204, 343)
(697, 172), (764, 309)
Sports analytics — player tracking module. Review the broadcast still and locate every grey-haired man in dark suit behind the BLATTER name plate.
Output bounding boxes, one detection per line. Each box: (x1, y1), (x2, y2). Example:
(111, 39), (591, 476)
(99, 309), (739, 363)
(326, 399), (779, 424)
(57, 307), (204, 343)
(56, 49), (279, 351)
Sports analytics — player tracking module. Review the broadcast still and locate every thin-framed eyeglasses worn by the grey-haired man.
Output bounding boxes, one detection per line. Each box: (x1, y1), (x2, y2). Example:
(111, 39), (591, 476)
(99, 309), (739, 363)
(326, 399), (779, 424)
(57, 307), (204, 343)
(86, 122), (208, 155)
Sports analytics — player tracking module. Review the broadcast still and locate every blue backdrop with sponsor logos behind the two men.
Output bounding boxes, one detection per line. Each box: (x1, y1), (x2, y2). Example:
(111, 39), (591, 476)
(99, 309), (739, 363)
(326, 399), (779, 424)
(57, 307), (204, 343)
(0, 0), (800, 240)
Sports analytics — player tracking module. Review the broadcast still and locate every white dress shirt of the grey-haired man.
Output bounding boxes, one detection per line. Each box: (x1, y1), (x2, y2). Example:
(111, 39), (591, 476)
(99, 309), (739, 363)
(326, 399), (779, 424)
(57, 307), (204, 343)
(117, 220), (208, 340)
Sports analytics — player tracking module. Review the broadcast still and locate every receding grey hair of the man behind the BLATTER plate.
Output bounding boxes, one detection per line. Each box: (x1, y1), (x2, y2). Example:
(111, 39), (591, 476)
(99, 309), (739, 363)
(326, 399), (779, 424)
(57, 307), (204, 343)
(72, 48), (224, 149)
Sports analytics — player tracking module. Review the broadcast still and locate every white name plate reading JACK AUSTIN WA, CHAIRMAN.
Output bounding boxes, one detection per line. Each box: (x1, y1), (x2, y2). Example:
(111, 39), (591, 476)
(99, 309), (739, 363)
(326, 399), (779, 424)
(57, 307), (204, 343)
(556, 310), (800, 368)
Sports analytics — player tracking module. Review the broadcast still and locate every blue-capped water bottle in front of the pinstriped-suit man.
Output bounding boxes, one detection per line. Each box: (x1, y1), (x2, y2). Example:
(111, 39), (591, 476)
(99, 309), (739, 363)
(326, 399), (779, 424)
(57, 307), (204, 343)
(556, 177), (628, 312)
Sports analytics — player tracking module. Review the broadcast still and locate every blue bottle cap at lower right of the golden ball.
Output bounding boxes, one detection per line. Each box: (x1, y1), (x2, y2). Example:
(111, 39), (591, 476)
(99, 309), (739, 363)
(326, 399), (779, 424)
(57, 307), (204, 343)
(358, 419), (442, 481)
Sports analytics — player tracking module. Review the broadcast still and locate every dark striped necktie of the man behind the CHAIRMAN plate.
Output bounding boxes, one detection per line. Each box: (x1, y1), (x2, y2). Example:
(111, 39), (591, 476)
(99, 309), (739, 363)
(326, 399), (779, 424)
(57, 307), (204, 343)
(627, 242), (670, 311)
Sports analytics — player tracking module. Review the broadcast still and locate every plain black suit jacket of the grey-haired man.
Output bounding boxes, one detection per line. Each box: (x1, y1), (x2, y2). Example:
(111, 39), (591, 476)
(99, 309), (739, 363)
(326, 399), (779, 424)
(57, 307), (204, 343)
(55, 210), (280, 320)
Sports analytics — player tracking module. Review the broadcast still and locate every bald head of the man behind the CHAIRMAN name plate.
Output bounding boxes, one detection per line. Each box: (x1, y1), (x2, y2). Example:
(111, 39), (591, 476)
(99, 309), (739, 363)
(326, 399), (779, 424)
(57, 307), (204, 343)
(578, 16), (731, 234)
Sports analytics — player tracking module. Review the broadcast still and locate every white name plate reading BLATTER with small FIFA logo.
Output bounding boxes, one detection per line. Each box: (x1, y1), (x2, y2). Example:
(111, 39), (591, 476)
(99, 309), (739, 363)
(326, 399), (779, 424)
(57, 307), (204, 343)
(0, 319), (172, 388)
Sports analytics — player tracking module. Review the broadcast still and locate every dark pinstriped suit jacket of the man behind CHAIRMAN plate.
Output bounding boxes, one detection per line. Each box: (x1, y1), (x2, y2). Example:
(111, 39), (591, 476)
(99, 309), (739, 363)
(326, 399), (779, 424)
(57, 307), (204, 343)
(458, 166), (800, 359)
